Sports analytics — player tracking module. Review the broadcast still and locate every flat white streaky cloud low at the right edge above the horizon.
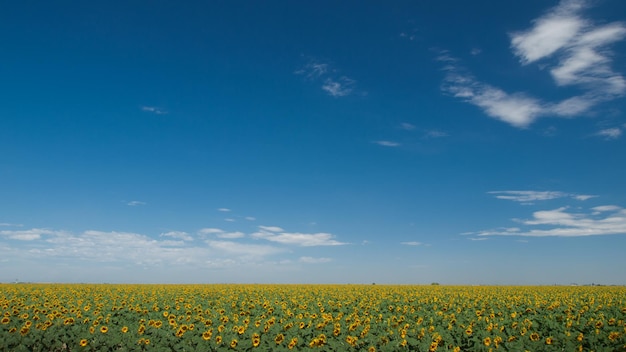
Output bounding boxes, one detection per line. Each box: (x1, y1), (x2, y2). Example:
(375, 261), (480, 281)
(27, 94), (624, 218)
(473, 205), (626, 237)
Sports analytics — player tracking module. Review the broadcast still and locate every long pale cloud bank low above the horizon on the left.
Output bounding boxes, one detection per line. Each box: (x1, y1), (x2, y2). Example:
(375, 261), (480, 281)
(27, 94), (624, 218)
(0, 226), (345, 268)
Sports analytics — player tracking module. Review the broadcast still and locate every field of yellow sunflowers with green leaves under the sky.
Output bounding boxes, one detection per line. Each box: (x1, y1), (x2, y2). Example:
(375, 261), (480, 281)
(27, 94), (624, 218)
(0, 284), (626, 351)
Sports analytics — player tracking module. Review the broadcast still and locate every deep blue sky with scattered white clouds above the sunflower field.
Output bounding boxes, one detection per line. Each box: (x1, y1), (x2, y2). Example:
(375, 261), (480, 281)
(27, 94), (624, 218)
(0, 0), (626, 284)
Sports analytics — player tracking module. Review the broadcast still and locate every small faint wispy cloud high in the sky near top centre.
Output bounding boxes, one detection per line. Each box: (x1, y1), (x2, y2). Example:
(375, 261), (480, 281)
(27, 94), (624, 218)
(294, 58), (356, 98)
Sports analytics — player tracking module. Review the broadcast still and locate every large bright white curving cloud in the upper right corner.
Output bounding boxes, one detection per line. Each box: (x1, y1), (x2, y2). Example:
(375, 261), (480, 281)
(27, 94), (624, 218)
(438, 0), (626, 128)
